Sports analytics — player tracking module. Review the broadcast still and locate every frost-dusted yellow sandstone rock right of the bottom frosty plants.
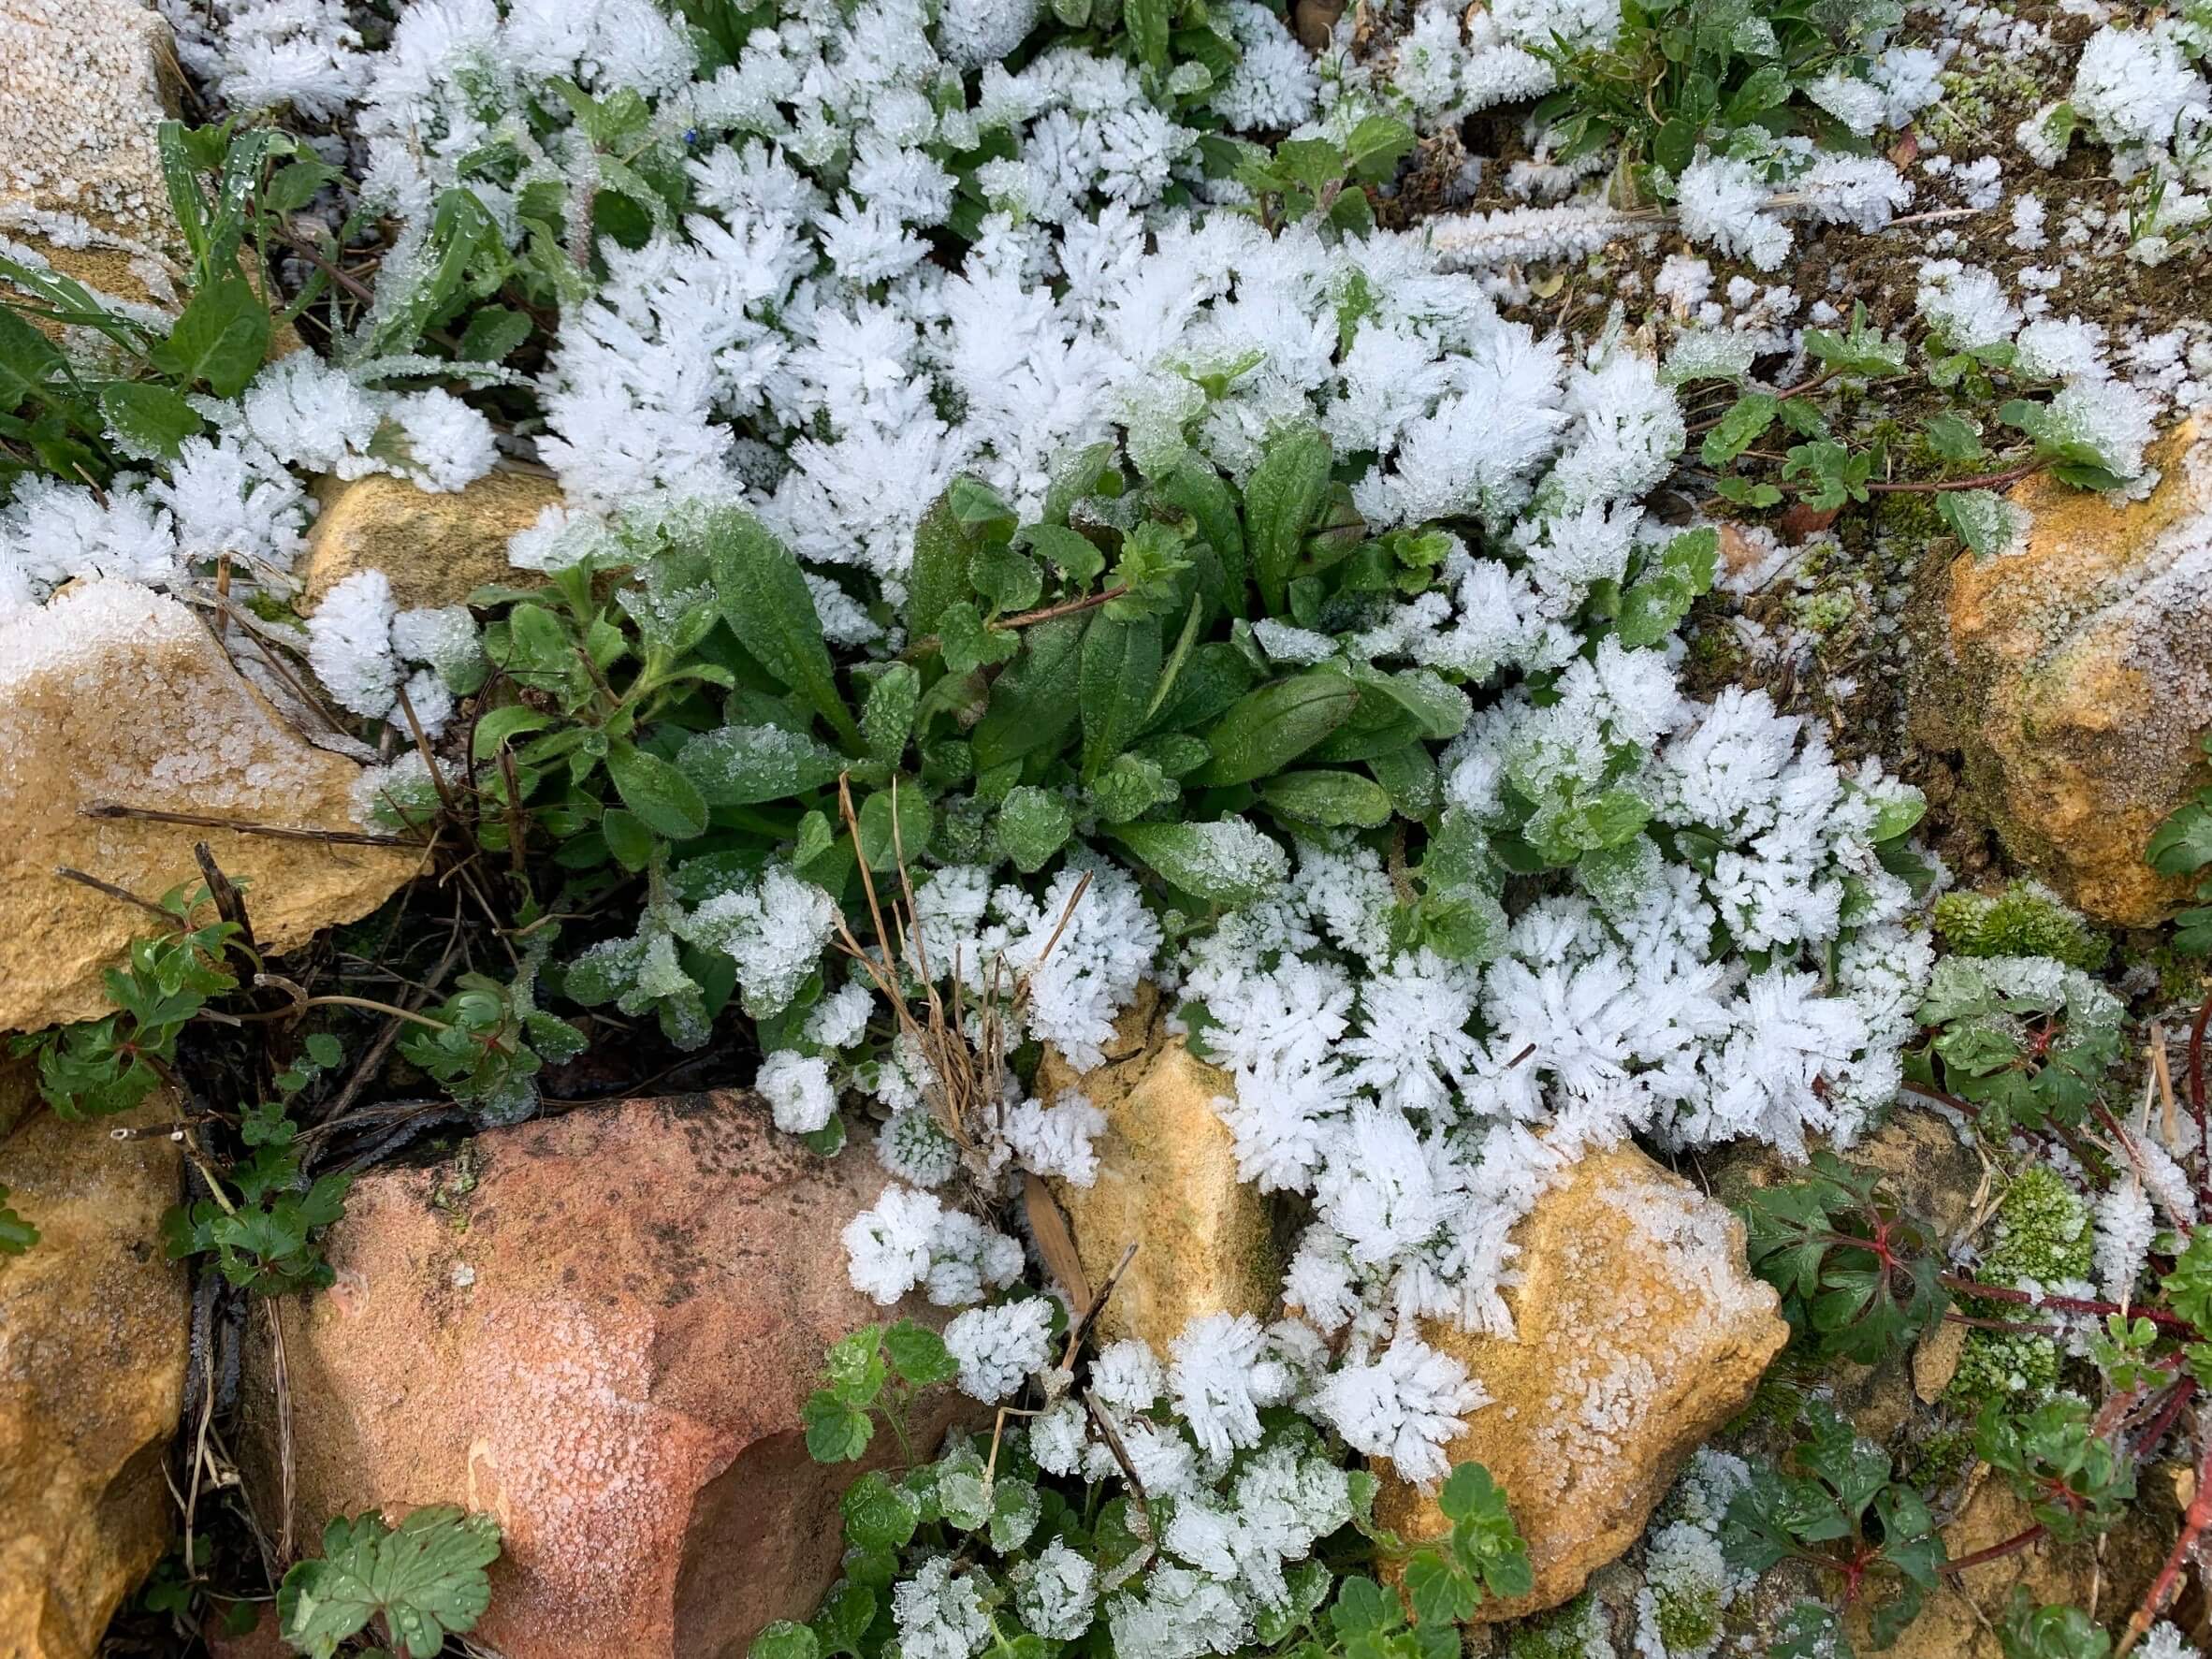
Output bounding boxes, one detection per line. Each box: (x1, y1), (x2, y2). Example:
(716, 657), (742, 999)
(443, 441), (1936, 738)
(1375, 1146), (1789, 1623)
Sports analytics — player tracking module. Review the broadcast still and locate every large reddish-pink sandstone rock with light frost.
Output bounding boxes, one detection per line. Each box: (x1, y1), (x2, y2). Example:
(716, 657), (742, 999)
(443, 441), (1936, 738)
(245, 1093), (953, 1659)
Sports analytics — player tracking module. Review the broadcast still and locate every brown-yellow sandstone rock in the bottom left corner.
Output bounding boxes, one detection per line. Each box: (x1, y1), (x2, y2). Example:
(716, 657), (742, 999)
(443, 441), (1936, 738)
(0, 1097), (190, 1659)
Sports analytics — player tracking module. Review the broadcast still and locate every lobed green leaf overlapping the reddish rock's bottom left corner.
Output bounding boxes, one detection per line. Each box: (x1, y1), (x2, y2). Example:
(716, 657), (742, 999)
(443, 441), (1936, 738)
(277, 1505), (500, 1659)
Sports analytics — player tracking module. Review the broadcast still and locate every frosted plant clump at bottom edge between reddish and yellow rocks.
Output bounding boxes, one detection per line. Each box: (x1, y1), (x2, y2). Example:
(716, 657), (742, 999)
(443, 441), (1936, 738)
(752, 1299), (1531, 1659)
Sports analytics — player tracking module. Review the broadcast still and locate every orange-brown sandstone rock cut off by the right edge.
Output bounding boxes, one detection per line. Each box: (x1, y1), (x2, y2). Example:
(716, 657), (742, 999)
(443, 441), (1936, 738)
(1914, 423), (2212, 927)
